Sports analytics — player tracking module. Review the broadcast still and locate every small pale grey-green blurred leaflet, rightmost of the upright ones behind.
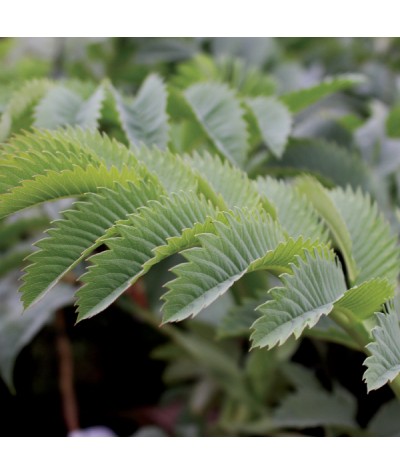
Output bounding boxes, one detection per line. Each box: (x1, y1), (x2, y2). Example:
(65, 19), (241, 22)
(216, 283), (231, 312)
(246, 97), (292, 158)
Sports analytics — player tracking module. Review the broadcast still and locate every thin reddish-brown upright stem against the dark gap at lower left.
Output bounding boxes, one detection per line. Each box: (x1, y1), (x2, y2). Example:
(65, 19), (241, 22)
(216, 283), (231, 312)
(56, 311), (79, 432)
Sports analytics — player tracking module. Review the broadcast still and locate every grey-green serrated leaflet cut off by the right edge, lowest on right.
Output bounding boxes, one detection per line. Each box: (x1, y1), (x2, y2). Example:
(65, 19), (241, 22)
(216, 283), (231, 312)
(364, 305), (400, 392)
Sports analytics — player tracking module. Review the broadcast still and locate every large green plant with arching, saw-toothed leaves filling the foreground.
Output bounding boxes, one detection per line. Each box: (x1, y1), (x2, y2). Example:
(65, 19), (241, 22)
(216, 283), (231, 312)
(0, 42), (400, 436)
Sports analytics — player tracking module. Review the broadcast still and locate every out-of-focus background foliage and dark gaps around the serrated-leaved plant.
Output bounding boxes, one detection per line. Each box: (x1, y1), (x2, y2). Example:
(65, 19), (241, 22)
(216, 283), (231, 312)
(0, 38), (400, 436)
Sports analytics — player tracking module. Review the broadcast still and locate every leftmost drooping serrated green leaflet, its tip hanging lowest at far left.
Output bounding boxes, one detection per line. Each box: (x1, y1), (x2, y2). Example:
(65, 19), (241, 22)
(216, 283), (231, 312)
(20, 181), (160, 308)
